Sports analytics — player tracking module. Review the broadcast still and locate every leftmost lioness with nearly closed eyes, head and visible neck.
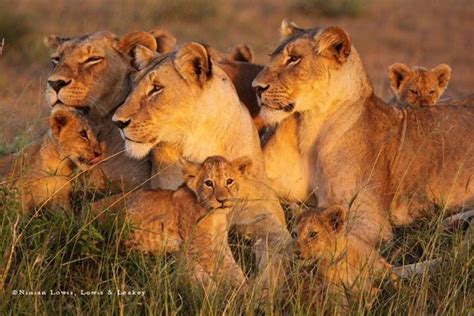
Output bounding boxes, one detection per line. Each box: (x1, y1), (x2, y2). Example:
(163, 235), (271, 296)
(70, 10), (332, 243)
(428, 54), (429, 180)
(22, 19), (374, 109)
(45, 32), (176, 189)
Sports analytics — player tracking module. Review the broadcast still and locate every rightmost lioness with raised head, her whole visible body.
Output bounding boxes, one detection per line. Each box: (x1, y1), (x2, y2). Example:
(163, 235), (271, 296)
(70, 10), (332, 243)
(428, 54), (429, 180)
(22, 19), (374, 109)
(253, 22), (474, 244)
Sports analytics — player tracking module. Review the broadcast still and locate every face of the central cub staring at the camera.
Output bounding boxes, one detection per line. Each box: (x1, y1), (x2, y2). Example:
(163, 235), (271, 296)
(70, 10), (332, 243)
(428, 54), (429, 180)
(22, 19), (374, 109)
(181, 156), (252, 211)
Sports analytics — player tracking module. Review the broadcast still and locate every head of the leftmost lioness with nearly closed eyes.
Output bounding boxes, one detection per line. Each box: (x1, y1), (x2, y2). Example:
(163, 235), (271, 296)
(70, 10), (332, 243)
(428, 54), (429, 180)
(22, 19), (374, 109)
(45, 32), (174, 117)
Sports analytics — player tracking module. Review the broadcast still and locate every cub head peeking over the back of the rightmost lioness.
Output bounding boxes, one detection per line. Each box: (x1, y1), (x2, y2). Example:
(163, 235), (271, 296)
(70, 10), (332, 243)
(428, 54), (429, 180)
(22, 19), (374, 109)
(388, 63), (451, 107)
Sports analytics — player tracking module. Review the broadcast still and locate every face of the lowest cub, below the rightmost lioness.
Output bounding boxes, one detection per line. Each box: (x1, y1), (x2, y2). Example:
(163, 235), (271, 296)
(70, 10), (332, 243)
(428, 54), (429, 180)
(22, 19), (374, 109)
(293, 206), (346, 262)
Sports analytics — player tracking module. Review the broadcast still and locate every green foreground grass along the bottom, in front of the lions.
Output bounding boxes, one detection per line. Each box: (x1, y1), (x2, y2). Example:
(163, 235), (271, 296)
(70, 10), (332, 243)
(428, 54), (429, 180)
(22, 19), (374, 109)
(0, 180), (474, 315)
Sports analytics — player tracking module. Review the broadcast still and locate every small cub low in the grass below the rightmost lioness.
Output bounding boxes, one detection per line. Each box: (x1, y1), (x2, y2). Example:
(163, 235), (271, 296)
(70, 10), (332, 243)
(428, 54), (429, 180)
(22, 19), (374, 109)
(293, 206), (397, 307)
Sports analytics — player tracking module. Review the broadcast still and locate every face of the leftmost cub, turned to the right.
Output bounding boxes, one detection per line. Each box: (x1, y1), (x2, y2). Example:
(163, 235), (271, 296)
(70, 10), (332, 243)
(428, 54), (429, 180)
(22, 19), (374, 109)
(49, 106), (105, 170)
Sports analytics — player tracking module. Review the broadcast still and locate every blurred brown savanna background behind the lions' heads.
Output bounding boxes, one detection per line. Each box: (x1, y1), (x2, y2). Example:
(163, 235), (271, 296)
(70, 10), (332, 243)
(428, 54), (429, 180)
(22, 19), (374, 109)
(0, 0), (474, 152)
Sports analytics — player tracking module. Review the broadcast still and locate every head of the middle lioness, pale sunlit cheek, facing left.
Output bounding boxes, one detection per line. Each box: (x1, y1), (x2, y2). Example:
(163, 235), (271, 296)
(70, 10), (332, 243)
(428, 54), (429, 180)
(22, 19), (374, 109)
(113, 43), (244, 161)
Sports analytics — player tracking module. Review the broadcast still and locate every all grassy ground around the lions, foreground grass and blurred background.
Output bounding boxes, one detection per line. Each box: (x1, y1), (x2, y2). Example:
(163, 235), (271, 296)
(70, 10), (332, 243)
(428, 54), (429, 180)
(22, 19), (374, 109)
(0, 0), (474, 315)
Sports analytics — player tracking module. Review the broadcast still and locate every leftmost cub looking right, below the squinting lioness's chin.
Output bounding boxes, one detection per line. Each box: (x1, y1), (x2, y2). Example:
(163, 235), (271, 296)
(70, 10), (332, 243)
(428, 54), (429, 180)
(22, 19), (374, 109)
(6, 106), (103, 213)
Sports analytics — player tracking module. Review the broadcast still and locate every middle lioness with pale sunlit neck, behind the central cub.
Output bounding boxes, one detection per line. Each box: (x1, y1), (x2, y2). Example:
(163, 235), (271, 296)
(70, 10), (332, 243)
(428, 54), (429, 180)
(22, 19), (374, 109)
(113, 43), (290, 296)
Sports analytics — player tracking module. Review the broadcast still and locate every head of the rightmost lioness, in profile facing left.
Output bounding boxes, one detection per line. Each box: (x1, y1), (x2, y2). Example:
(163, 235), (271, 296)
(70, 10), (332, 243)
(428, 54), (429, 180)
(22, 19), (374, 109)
(252, 21), (372, 123)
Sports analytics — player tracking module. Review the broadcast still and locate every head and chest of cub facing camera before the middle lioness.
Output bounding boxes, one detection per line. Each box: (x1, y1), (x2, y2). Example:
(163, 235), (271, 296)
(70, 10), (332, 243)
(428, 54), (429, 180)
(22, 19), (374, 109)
(182, 156), (252, 291)
